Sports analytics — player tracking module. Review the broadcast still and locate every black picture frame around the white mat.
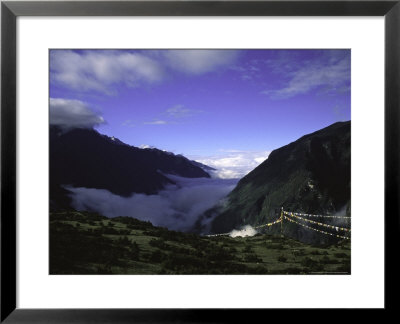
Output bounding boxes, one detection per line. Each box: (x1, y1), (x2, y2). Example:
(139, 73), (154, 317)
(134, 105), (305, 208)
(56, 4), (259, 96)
(0, 0), (400, 323)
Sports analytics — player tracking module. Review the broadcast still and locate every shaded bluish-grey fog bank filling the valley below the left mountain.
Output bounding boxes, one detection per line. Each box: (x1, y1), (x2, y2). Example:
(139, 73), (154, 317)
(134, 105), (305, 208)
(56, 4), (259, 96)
(66, 176), (237, 231)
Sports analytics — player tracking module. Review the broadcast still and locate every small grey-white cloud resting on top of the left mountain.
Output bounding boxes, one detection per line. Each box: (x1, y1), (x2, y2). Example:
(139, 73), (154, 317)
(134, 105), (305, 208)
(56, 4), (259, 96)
(50, 98), (105, 128)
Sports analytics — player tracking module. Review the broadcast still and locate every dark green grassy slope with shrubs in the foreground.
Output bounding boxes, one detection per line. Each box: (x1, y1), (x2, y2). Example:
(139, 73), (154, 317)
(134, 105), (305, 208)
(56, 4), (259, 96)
(50, 211), (350, 274)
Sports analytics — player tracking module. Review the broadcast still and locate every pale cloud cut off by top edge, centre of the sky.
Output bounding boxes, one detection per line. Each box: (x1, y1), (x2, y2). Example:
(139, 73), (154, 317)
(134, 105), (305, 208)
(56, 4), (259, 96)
(163, 50), (238, 75)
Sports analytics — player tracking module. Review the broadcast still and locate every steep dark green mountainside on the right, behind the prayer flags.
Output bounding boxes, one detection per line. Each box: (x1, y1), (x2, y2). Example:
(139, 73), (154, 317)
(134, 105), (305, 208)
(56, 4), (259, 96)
(212, 121), (350, 241)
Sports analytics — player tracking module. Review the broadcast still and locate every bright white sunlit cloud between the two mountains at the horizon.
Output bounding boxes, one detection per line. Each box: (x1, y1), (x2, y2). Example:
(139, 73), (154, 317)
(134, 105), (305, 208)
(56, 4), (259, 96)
(192, 150), (270, 179)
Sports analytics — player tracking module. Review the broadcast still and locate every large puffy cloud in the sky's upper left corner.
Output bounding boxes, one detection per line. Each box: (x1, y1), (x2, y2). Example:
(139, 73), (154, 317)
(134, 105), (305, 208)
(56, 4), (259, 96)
(50, 50), (163, 94)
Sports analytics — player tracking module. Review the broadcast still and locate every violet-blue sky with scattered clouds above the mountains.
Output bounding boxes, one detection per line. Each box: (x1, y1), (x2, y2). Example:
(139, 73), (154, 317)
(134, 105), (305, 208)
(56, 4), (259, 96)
(50, 50), (350, 177)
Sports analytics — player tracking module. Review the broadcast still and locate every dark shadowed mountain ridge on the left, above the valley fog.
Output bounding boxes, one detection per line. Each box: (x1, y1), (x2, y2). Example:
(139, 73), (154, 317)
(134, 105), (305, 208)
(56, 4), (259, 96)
(50, 126), (210, 209)
